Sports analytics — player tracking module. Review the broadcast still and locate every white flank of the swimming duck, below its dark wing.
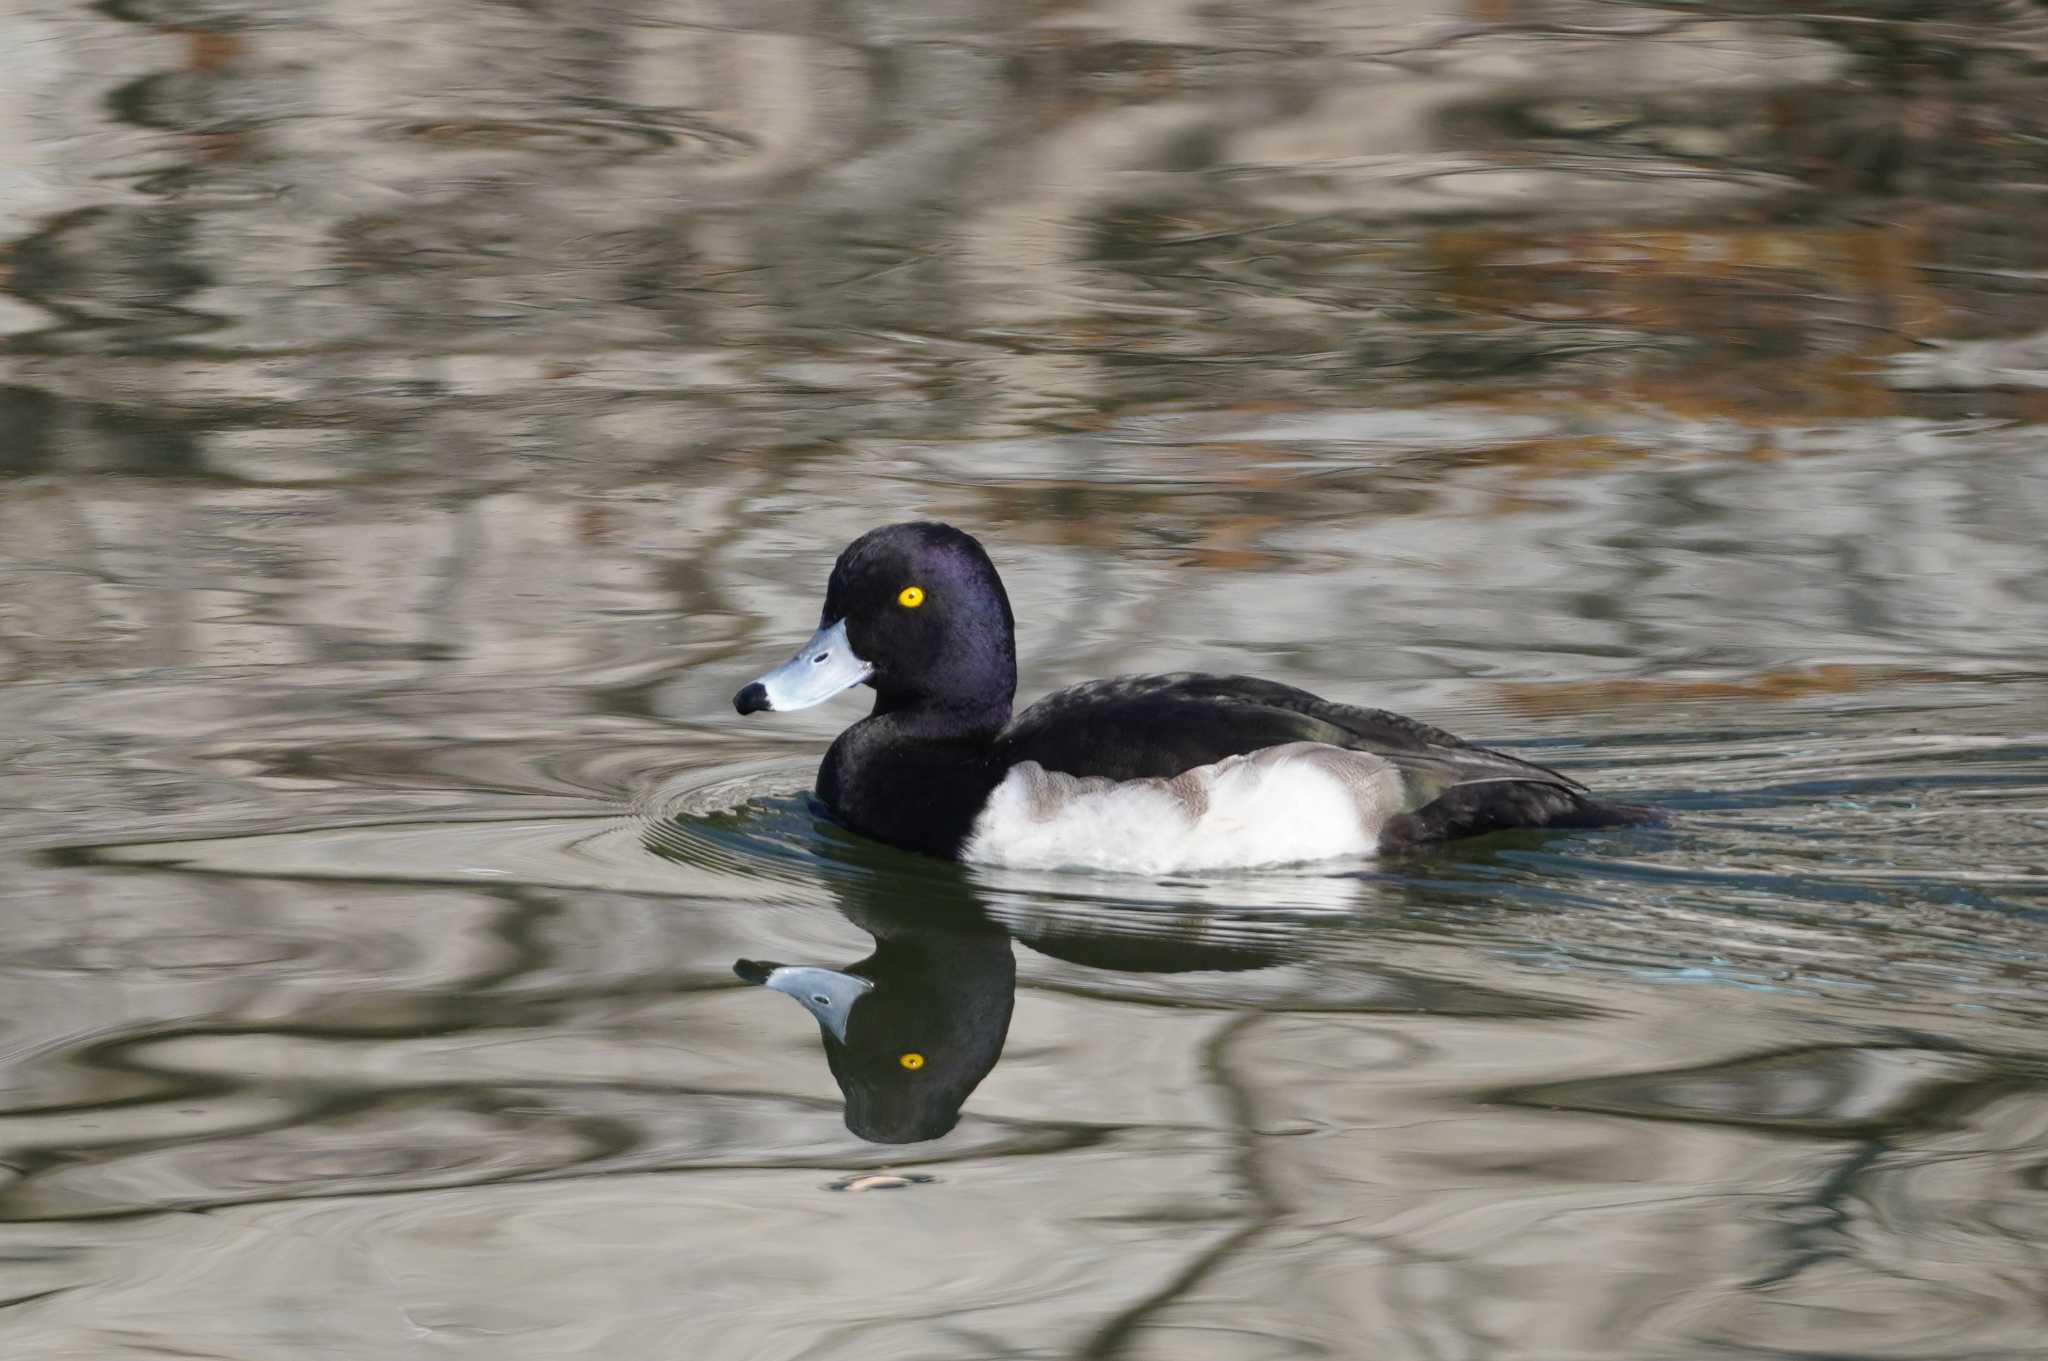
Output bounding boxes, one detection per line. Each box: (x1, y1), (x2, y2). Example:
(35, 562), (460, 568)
(965, 743), (1401, 874)
